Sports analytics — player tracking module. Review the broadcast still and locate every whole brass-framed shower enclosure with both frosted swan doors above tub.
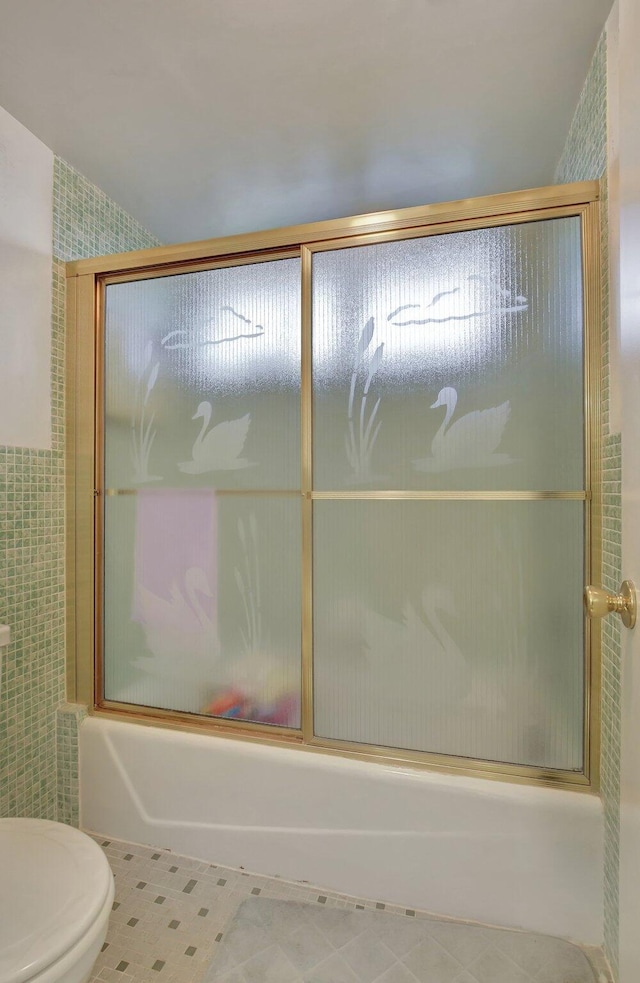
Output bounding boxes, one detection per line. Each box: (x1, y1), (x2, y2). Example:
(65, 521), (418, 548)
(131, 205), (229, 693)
(68, 183), (601, 786)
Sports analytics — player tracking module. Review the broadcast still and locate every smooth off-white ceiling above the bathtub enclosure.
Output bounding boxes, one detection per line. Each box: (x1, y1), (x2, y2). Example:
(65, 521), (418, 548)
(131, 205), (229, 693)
(0, 0), (612, 242)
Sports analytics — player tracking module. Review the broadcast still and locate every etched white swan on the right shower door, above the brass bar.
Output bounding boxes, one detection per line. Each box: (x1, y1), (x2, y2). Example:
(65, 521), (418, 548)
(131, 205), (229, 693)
(413, 386), (514, 471)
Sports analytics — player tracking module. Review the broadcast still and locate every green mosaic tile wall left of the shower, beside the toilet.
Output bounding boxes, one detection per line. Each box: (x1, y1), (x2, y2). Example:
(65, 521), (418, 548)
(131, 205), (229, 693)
(0, 159), (158, 824)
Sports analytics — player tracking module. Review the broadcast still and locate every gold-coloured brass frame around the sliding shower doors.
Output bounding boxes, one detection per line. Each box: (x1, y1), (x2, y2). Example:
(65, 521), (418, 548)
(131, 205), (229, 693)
(67, 182), (602, 791)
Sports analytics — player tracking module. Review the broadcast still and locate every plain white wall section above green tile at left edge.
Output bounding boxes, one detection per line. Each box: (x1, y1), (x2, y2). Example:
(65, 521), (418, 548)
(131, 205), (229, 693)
(0, 108), (53, 449)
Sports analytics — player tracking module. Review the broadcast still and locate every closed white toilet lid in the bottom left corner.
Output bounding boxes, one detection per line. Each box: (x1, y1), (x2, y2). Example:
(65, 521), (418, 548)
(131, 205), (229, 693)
(0, 819), (112, 983)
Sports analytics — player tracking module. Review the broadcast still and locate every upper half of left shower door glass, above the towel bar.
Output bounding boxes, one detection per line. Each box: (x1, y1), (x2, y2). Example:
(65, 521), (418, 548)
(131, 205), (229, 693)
(105, 259), (300, 489)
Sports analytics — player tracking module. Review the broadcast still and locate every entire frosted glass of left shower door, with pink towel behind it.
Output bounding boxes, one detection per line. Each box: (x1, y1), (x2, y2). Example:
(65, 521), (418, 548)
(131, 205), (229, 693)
(104, 258), (300, 728)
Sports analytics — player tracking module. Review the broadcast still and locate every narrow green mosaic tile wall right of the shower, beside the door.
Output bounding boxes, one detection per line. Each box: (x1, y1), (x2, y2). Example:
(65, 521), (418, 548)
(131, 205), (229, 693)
(556, 34), (622, 979)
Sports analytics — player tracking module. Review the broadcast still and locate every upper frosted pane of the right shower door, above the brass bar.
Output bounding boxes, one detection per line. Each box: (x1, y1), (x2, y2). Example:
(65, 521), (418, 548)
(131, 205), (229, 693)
(313, 218), (584, 490)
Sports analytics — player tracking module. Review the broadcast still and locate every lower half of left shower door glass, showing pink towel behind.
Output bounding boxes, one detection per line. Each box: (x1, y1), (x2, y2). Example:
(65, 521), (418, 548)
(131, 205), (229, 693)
(104, 489), (300, 728)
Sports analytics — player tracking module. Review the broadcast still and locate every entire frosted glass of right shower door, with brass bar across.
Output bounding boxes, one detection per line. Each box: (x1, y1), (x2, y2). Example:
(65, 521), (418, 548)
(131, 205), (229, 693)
(311, 218), (585, 770)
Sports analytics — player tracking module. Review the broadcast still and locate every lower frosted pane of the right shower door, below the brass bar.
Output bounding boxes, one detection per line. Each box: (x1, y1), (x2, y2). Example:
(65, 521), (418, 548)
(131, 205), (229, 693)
(314, 501), (584, 771)
